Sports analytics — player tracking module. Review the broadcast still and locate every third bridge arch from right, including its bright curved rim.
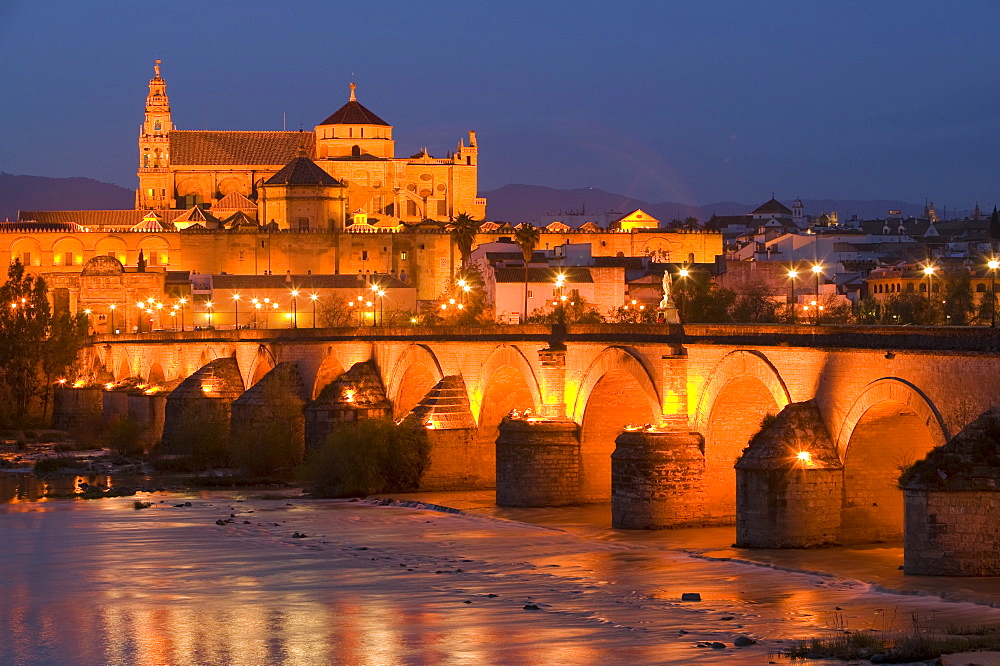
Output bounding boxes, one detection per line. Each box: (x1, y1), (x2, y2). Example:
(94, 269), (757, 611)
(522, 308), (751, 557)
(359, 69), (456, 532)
(573, 347), (663, 502)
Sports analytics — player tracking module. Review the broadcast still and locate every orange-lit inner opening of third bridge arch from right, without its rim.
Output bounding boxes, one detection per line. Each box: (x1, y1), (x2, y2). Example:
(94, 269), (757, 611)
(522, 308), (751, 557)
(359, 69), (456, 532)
(580, 369), (658, 502)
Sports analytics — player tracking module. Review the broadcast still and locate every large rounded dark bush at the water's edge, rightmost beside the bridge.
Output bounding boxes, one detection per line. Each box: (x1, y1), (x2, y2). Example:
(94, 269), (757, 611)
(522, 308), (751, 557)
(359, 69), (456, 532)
(302, 419), (430, 497)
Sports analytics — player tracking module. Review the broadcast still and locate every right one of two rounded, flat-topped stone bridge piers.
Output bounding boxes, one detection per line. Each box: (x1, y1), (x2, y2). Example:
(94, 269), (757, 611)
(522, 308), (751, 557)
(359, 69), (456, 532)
(611, 429), (705, 530)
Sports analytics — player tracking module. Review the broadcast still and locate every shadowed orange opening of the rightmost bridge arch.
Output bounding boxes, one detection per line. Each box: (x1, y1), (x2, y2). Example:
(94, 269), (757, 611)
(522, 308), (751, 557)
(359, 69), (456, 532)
(840, 401), (939, 543)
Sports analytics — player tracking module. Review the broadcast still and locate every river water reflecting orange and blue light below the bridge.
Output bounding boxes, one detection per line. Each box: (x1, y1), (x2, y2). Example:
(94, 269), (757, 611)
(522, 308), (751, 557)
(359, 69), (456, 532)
(0, 482), (1000, 664)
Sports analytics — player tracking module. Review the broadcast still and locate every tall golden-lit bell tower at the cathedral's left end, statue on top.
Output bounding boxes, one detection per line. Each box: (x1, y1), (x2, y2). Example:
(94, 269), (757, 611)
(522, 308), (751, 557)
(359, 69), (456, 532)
(136, 60), (174, 209)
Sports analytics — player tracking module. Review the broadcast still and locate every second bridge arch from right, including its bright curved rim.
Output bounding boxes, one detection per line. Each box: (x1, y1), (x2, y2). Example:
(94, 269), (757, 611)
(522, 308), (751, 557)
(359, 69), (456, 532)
(694, 349), (791, 523)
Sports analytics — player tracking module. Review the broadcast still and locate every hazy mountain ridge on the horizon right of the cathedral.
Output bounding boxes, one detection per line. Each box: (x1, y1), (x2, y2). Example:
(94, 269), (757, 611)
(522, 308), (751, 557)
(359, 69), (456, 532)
(481, 185), (923, 225)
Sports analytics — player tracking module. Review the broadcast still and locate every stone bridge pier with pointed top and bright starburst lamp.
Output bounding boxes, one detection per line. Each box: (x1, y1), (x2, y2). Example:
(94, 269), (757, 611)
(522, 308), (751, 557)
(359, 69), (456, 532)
(736, 401), (844, 548)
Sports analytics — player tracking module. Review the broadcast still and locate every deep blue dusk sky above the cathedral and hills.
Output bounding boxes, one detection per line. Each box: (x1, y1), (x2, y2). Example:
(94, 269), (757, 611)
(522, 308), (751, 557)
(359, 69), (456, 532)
(0, 0), (1000, 209)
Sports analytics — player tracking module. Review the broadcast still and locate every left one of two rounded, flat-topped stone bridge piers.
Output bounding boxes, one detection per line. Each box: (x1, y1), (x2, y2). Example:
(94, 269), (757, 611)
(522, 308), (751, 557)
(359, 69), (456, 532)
(496, 418), (580, 507)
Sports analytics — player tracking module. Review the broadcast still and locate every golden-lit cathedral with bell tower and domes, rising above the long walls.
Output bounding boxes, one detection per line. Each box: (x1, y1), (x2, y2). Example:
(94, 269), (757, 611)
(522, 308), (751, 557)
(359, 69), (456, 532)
(136, 61), (486, 226)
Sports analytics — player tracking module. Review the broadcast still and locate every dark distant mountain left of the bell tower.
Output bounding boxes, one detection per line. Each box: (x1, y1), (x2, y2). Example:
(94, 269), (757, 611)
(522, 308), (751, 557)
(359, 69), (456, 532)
(0, 172), (135, 220)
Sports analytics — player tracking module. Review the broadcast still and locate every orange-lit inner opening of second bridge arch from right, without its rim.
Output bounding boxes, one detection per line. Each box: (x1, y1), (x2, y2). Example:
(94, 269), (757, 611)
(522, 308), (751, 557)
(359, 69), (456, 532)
(704, 375), (781, 523)
